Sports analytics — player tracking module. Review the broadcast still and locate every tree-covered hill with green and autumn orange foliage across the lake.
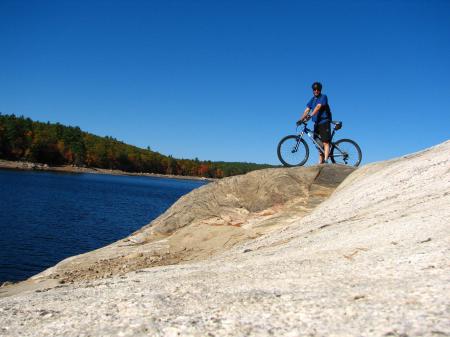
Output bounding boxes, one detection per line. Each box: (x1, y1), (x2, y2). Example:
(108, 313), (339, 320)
(0, 113), (271, 178)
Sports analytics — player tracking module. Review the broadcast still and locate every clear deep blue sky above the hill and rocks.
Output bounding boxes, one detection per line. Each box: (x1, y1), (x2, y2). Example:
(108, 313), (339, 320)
(0, 0), (450, 164)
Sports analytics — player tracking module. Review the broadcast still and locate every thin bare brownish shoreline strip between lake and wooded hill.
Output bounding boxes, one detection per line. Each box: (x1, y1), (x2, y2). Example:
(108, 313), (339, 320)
(0, 159), (217, 181)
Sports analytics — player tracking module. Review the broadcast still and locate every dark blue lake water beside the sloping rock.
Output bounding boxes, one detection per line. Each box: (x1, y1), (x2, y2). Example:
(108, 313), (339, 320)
(0, 170), (206, 282)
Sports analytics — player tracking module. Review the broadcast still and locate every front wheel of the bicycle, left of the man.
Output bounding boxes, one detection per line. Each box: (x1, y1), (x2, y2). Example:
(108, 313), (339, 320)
(277, 135), (309, 166)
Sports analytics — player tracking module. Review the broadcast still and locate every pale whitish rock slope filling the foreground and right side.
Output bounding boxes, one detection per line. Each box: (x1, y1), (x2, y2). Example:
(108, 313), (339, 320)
(0, 141), (450, 337)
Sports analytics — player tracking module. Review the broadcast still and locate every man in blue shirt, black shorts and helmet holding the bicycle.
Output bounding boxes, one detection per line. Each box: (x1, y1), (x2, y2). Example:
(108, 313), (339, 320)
(297, 82), (331, 164)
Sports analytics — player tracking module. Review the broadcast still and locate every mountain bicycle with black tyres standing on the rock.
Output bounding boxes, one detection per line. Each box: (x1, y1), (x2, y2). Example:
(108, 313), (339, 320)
(277, 121), (362, 167)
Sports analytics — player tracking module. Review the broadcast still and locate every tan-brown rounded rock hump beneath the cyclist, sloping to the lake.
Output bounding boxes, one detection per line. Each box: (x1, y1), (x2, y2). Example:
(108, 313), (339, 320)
(32, 165), (354, 282)
